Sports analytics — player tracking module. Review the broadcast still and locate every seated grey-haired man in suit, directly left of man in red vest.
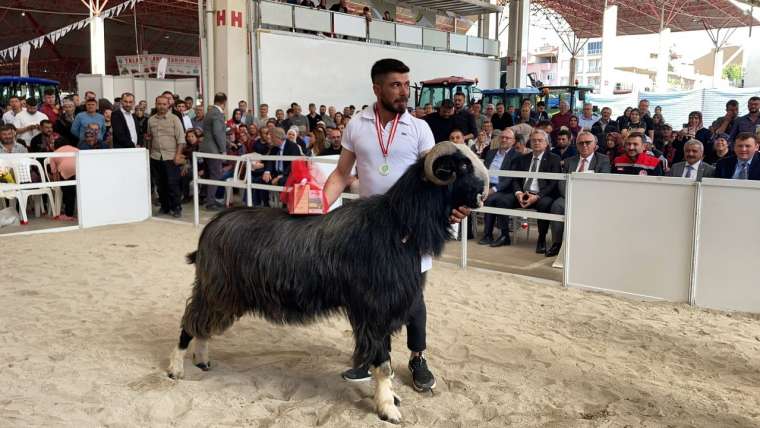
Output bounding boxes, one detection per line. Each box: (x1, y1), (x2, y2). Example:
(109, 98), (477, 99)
(546, 131), (610, 257)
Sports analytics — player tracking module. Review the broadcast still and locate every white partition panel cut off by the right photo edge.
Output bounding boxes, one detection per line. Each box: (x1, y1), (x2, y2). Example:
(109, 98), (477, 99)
(693, 178), (760, 313)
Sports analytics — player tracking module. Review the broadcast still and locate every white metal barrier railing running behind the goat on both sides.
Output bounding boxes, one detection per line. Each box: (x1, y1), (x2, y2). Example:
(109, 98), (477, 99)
(193, 152), (568, 269)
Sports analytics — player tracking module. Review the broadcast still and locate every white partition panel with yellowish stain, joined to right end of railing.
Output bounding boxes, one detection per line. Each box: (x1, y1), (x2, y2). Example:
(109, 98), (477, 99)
(565, 174), (696, 302)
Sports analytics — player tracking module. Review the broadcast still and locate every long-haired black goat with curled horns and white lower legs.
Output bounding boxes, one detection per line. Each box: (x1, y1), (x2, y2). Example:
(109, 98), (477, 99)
(168, 142), (488, 422)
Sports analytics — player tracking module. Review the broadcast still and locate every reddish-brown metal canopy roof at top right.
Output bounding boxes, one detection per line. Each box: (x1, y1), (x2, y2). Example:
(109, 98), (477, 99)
(535, 0), (758, 38)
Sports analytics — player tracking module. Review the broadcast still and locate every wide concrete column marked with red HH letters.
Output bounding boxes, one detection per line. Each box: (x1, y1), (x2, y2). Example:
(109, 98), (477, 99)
(212, 0), (251, 110)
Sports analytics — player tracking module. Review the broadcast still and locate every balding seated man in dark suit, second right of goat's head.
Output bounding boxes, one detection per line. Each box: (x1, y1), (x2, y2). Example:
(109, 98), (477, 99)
(486, 129), (561, 254)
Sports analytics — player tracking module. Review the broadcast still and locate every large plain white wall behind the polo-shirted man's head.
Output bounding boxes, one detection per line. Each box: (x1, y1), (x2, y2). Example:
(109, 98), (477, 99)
(254, 31), (499, 113)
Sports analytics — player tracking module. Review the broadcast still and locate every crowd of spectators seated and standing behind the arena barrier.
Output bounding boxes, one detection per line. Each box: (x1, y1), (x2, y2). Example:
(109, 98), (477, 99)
(0, 86), (760, 234)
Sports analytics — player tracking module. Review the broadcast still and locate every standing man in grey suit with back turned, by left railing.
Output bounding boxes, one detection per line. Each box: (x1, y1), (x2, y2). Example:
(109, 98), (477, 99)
(199, 92), (227, 210)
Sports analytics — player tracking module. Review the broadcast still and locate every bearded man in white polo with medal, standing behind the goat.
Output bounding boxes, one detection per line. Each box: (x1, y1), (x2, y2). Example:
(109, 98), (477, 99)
(325, 59), (470, 392)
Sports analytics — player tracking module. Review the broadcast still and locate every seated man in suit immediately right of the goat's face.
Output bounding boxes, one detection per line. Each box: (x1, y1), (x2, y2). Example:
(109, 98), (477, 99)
(479, 128), (522, 247)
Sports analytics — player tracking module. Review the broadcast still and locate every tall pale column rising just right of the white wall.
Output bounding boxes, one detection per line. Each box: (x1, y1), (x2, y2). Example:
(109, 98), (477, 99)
(507, 0), (530, 88)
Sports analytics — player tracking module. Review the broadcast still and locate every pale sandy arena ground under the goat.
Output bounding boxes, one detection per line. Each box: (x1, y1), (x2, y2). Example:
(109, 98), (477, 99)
(0, 220), (760, 427)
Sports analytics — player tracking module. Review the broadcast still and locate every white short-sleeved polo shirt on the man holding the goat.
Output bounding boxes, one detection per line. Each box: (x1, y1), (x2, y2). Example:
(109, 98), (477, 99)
(341, 104), (435, 198)
